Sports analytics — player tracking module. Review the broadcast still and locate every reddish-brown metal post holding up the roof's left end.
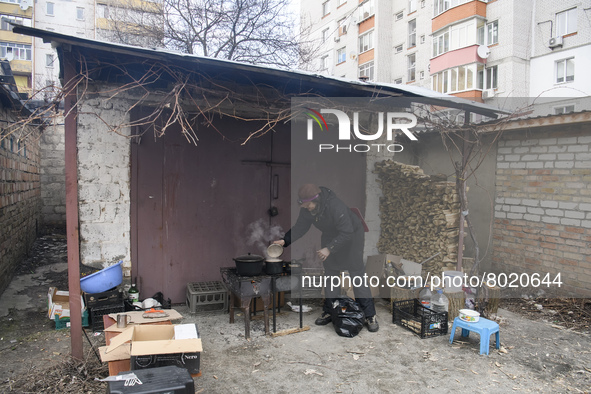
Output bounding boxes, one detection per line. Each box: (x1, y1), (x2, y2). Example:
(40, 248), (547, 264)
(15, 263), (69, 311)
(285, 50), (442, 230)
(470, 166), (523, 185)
(62, 47), (83, 360)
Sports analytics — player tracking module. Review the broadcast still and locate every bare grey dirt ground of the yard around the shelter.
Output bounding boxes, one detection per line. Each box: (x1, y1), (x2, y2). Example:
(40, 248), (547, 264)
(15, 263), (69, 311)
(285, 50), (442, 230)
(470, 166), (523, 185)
(0, 234), (591, 393)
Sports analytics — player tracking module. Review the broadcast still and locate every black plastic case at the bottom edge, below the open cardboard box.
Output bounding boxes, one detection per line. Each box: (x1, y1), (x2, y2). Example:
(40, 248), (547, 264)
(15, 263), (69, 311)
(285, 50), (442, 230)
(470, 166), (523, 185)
(107, 366), (195, 394)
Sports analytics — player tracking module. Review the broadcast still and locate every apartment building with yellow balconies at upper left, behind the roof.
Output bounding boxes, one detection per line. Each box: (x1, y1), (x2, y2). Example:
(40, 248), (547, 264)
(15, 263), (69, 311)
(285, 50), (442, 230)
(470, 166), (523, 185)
(0, 0), (162, 100)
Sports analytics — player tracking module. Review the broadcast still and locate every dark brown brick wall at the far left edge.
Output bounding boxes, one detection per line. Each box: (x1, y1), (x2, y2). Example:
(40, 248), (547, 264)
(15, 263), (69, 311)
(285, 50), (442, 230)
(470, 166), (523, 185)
(0, 108), (41, 294)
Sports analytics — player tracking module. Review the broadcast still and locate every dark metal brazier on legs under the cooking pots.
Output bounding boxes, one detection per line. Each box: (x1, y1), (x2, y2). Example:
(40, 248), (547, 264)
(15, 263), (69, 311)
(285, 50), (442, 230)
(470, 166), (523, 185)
(220, 267), (302, 339)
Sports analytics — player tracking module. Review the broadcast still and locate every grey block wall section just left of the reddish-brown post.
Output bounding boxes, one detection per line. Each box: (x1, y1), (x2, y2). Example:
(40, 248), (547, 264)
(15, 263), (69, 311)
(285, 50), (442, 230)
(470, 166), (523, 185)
(40, 117), (66, 229)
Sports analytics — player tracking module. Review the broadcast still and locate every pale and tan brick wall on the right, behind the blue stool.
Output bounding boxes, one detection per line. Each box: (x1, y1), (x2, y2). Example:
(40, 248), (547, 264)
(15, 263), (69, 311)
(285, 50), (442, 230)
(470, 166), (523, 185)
(493, 125), (591, 296)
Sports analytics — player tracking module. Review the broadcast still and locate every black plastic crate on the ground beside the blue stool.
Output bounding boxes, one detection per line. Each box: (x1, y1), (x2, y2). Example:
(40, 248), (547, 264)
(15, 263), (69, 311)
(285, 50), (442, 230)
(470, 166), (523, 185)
(392, 298), (448, 338)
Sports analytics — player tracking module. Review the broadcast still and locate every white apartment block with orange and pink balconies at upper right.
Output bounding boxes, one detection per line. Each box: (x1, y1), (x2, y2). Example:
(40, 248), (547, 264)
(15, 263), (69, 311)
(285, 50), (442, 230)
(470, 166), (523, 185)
(301, 0), (591, 104)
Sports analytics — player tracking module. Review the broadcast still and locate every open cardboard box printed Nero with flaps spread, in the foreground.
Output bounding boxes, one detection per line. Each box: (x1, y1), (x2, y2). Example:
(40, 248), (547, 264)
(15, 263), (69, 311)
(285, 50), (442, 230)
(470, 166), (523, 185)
(99, 324), (203, 374)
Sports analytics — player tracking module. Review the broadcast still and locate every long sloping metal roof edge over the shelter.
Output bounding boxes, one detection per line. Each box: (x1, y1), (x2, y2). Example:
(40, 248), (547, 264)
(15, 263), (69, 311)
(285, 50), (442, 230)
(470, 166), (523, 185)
(13, 25), (506, 118)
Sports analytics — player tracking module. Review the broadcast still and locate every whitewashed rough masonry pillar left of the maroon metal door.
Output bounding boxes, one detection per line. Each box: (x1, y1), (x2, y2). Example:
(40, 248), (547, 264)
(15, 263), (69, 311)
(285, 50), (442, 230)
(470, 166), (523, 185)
(78, 94), (135, 275)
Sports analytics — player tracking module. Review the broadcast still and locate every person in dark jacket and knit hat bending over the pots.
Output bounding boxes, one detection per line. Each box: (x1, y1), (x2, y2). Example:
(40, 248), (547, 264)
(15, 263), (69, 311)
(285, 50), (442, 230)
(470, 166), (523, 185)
(274, 183), (379, 332)
